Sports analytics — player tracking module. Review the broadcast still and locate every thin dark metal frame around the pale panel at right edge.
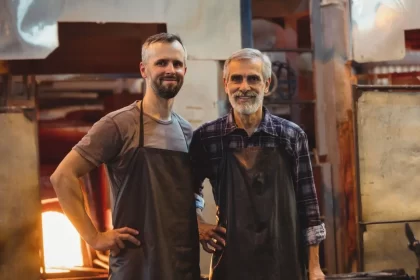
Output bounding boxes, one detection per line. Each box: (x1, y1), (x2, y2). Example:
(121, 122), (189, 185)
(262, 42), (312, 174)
(352, 85), (420, 271)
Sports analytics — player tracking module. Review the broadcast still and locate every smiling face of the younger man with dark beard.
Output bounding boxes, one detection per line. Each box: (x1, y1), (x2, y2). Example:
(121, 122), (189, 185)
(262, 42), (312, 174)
(140, 41), (187, 99)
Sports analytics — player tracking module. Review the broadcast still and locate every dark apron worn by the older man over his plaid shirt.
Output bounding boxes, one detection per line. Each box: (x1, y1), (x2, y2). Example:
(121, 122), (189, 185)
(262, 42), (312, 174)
(210, 141), (307, 280)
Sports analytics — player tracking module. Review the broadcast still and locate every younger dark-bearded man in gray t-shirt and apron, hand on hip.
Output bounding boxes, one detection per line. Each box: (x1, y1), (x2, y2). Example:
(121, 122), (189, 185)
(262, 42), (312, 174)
(51, 33), (200, 280)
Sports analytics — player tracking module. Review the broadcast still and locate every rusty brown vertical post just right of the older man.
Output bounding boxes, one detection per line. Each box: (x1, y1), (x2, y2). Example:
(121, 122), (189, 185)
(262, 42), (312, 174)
(311, 0), (358, 274)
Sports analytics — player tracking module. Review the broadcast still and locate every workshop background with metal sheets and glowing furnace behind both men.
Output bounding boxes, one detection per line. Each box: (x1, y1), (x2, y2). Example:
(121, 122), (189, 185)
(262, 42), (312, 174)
(0, 0), (420, 280)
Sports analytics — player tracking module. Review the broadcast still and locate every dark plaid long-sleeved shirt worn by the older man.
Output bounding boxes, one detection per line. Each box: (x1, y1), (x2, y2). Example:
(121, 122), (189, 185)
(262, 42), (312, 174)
(190, 108), (326, 245)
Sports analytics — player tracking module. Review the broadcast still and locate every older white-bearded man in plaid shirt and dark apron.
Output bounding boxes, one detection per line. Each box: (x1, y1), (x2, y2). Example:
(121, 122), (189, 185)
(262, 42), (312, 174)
(190, 49), (325, 280)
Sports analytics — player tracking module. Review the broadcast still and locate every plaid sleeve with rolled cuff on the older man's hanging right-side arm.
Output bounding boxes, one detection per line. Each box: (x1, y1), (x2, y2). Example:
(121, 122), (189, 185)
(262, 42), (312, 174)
(294, 132), (326, 245)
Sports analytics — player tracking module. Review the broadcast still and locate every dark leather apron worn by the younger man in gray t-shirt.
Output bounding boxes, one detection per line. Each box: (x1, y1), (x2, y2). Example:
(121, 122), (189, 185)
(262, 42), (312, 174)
(109, 104), (200, 280)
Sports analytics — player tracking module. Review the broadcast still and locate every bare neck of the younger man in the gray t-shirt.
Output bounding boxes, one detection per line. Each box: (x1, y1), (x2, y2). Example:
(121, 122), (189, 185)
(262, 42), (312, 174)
(139, 88), (174, 121)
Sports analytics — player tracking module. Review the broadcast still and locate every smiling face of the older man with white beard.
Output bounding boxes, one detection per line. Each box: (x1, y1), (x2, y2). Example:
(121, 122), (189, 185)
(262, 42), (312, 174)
(224, 58), (270, 115)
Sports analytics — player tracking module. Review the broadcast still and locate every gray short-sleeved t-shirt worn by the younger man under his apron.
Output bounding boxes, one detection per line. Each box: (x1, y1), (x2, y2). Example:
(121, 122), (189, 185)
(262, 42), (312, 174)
(73, 102), (193, 202)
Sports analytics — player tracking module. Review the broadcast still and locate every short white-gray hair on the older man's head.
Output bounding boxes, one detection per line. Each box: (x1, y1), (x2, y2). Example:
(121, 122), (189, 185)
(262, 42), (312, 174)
(223, 48), (271, 81)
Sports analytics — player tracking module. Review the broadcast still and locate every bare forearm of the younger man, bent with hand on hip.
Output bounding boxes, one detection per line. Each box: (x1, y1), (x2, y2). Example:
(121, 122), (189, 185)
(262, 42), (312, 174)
(51, 174), (98, 246)
